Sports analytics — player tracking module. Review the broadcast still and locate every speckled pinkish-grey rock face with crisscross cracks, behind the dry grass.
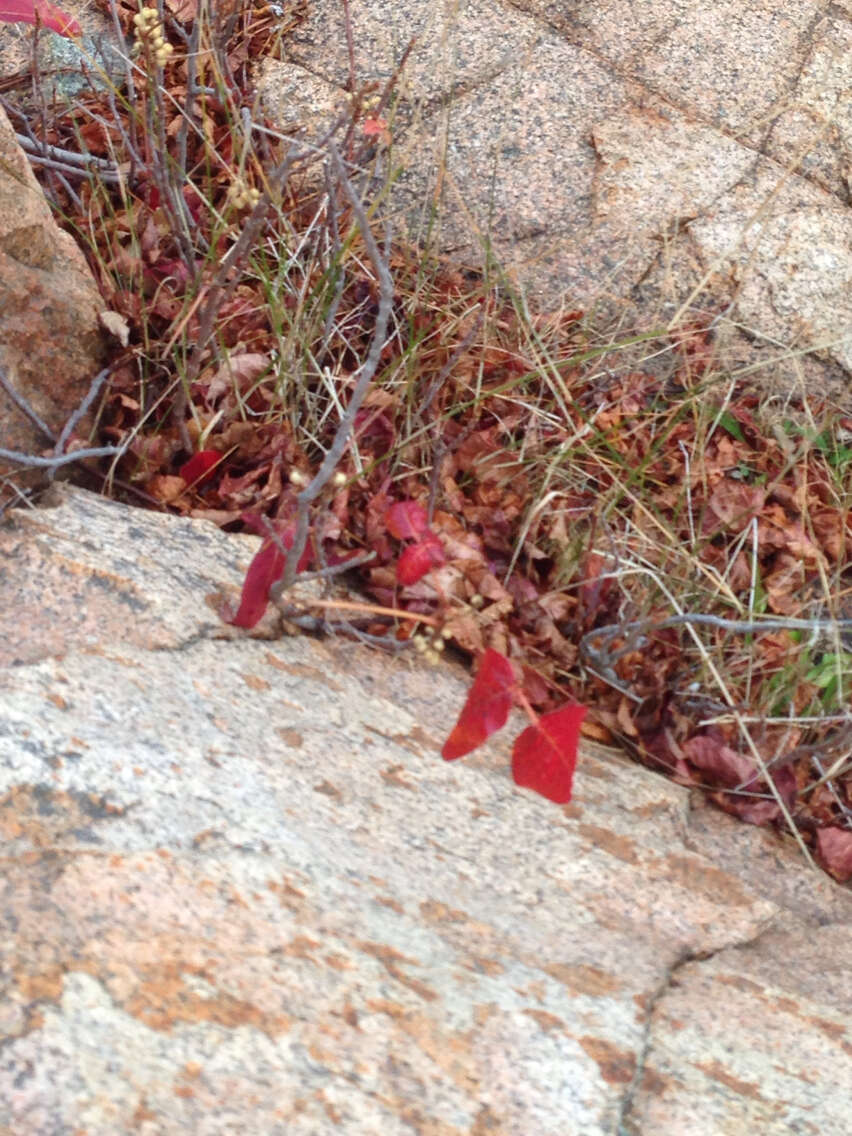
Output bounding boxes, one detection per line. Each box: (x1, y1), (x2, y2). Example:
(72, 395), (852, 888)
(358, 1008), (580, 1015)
(259, 0), (852, 406)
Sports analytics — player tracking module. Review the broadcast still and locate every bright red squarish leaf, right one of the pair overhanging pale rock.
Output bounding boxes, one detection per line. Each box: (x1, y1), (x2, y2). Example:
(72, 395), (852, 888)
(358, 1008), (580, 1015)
(512, 705), (586, 804)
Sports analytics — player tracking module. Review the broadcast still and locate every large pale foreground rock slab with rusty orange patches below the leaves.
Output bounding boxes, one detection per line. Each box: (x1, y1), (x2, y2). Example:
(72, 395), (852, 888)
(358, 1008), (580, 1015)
(0, 486), (852, 1136)
